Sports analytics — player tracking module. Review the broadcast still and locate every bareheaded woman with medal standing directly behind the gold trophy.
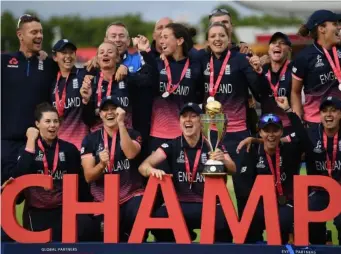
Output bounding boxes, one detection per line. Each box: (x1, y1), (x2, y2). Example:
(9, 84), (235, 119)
(200, 22), (271, 215)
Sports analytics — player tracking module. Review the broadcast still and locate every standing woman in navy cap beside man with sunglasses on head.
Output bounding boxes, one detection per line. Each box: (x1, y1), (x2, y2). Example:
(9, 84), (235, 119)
(50, 39), (89, 150)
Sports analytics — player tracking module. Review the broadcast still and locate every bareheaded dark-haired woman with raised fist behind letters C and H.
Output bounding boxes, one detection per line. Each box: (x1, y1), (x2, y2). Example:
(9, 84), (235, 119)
(13, 103), (92, 241)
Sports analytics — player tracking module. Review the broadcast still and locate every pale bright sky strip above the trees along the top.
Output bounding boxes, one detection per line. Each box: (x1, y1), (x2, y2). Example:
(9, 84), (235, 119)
(1, 1), (255, 24)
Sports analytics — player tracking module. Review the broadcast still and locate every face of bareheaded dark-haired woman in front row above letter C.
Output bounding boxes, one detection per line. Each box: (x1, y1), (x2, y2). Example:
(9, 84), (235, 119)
(36, 112), (60, 142)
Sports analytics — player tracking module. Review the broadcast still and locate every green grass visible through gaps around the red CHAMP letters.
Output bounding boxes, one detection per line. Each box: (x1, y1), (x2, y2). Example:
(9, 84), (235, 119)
(16, 168), (338, 245)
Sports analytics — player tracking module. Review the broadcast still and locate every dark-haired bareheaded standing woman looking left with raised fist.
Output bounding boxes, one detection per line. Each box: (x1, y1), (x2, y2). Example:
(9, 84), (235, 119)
(133, 23), (201, 171)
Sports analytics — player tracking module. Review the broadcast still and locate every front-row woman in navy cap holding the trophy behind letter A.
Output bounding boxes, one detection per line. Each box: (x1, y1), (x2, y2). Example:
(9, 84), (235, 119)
(139, 103), (236, 242)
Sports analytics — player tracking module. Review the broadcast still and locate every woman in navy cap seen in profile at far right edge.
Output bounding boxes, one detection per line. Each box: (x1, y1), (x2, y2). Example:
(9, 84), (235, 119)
(291, 10), (341, 126)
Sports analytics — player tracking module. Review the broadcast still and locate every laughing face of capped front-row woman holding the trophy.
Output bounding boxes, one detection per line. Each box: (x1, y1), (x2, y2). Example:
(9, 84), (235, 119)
(180, 111), (201, 137)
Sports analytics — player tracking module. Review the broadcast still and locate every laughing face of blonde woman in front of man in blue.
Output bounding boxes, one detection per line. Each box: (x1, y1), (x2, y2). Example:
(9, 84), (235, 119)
(97, 42), (118, 70)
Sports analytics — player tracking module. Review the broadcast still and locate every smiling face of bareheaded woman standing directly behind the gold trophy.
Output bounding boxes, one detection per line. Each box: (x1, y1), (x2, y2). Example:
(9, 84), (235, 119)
(207, 26), (229, 54)
